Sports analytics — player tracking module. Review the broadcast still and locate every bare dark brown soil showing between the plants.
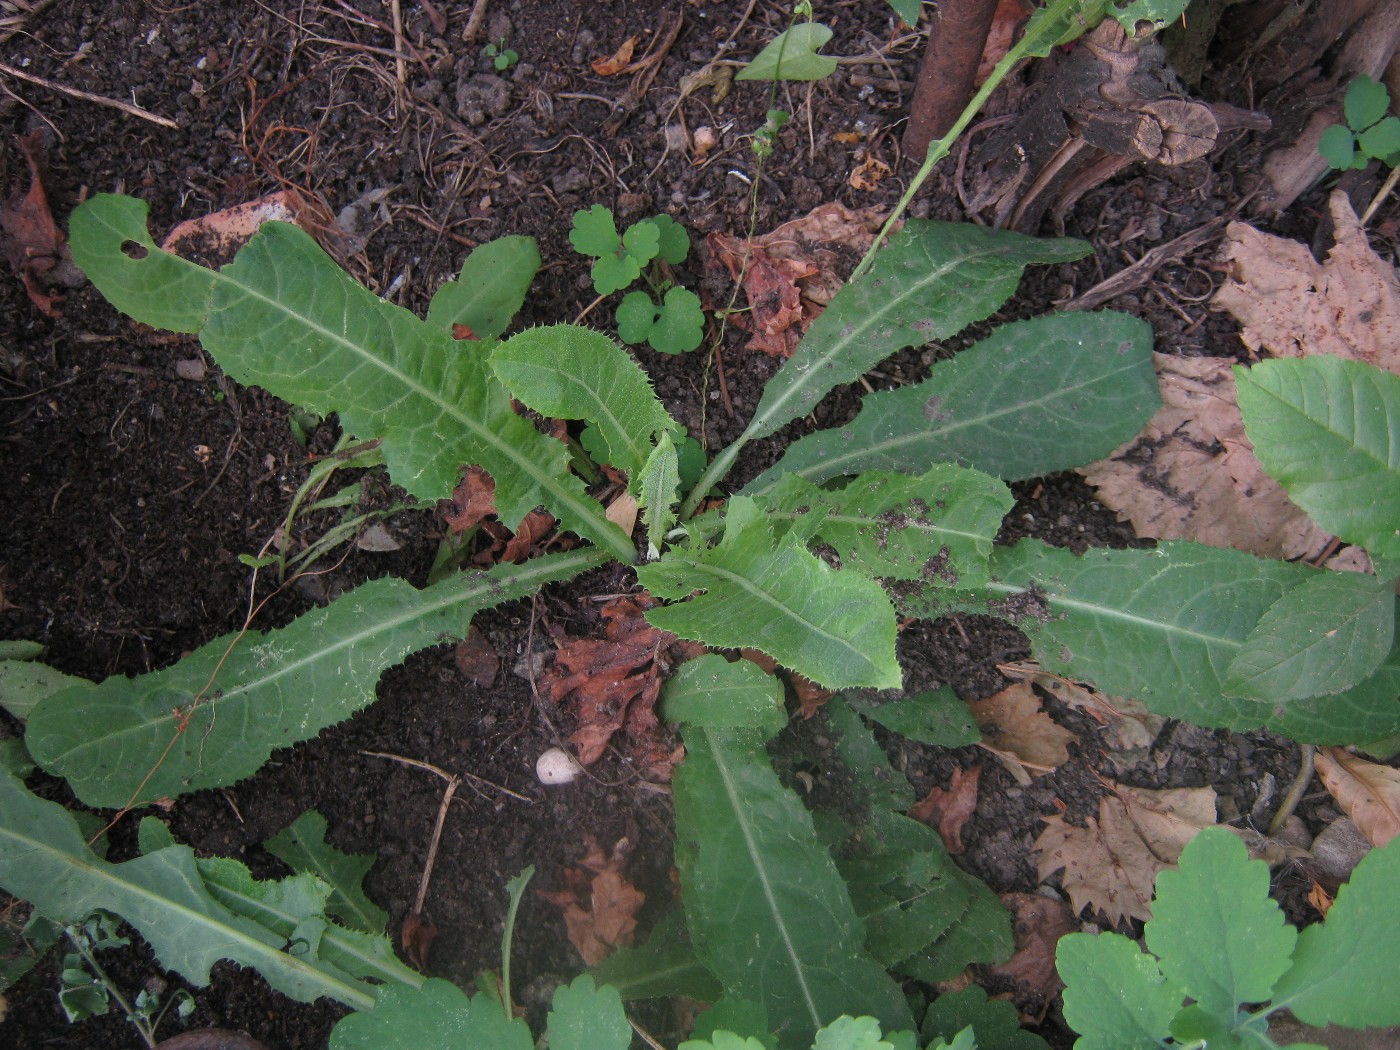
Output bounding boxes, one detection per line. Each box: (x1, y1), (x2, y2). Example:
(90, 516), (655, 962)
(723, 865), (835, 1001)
(0, 0), (1383, 1050)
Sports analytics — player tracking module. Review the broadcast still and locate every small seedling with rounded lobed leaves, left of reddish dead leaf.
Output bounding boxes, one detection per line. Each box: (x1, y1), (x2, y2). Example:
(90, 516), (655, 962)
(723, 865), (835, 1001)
(568, 204), (704, 354)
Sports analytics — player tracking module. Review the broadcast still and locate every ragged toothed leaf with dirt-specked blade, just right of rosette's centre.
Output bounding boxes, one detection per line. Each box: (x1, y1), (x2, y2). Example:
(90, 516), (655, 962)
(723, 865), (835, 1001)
(759, 463), (1015, 588)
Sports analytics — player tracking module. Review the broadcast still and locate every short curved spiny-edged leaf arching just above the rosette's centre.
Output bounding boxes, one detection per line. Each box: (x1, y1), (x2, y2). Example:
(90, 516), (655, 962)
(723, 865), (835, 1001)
(491, 325), (680, 478)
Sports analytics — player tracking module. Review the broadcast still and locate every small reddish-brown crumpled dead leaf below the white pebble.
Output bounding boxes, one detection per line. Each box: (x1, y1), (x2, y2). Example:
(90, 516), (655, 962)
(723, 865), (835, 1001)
(539, 834), (647, 966)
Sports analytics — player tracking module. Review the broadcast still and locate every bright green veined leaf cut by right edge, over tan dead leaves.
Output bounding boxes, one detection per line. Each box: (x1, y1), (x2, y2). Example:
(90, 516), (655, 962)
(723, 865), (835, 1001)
(1235, 354), (1400, 559)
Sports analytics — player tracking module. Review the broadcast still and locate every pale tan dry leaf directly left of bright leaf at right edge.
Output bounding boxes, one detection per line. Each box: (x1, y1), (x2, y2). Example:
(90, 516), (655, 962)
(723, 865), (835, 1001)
(1079, 354), (1331, 560)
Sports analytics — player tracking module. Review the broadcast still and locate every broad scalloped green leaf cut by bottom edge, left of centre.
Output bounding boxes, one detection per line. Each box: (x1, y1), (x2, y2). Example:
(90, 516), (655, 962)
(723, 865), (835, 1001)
(330, 977), (535, 1050)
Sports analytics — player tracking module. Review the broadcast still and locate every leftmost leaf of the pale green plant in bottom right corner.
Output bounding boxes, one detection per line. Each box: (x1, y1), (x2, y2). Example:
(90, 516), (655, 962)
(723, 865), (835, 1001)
(1056, 934), (1184, 1050)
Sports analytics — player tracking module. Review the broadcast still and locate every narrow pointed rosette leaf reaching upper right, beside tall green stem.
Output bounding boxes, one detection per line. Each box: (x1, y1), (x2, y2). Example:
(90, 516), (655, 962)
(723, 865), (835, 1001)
(683, 218), (1092, 517)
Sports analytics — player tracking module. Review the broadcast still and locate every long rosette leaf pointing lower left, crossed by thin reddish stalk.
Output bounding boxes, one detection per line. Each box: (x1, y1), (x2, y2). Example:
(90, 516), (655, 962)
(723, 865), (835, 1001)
(25, 550), (606, 806)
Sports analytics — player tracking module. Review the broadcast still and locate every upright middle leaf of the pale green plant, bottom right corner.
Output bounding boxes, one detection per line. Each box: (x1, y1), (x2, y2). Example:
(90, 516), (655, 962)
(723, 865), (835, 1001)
(1147, 827), (1298, 1023)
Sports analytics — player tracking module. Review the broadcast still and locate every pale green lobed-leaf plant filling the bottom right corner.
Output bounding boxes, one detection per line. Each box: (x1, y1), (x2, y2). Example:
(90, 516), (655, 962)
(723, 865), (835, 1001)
(1056, 827), (1400, 1050)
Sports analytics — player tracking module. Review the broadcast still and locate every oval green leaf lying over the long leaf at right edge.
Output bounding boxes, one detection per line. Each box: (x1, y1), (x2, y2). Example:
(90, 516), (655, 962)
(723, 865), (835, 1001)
(1225, 573), (1396, 703)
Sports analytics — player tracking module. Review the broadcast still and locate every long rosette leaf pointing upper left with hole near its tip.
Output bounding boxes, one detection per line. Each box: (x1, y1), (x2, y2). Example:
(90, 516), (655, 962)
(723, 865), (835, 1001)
(71, 195), (633, 561)
